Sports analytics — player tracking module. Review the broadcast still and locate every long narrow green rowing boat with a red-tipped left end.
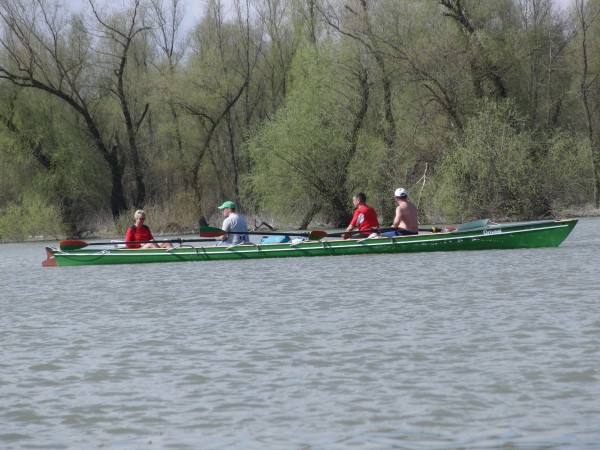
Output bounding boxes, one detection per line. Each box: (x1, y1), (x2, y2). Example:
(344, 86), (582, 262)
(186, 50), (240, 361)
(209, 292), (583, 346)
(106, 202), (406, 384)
(42, 219), (577, 267)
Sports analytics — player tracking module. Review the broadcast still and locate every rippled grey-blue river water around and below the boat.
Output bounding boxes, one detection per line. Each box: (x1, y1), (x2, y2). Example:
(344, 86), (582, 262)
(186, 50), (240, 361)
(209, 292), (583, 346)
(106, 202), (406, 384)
(0, 218), (600, 449)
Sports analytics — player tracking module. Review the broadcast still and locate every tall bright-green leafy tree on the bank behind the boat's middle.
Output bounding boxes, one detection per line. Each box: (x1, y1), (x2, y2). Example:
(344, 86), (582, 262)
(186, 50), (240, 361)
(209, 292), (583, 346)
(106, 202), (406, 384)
(247, 46), (351, 223)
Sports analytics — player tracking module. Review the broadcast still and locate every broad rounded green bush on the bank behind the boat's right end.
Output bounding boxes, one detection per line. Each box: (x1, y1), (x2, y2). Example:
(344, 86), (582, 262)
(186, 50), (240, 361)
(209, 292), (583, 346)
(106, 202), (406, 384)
(427, 101), (549, 222)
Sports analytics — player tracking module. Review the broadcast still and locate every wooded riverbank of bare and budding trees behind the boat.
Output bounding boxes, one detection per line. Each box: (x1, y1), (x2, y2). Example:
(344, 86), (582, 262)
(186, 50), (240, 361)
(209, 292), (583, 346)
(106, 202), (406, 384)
(0, 0), (600, 242)
